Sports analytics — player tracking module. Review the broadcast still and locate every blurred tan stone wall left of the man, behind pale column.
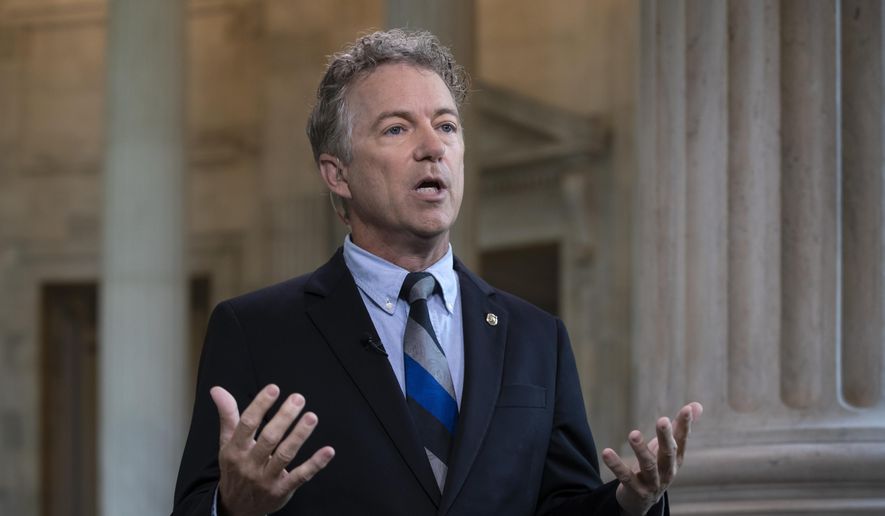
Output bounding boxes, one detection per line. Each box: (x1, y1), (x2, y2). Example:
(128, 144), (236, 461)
(0, 0), (381, 515)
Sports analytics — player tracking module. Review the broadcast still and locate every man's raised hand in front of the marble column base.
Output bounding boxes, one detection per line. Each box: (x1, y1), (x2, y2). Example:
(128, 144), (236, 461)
(602, 402), (704, 516)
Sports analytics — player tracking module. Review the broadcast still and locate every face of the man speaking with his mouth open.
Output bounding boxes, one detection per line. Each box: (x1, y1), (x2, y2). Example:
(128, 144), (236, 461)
(338, 64), (464, 255)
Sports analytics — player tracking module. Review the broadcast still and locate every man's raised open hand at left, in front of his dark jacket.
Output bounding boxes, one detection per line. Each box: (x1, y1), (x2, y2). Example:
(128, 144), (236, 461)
(209, 385), (335, 516)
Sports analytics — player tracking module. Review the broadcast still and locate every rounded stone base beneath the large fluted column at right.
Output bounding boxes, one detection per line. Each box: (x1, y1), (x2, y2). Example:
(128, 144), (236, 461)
(670, 442), (885, 516)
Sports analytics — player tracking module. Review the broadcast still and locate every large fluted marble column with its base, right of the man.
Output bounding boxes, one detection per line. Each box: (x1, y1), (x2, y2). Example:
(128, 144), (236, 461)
(632, 0), (885, 515)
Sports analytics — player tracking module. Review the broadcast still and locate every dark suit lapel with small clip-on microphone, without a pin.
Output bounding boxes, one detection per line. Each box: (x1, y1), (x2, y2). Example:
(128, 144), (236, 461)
(306, 250), (440, 506)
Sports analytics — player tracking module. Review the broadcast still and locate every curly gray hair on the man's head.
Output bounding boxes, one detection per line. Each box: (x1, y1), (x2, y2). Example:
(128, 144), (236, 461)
(307, 29), (468, 164)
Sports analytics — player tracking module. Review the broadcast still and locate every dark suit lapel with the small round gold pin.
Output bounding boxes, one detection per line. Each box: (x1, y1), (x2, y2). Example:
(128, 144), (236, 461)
(439, 261), (508, 514)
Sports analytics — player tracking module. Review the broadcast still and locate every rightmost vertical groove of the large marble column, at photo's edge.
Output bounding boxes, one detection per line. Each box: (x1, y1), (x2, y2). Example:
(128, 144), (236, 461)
(839, 0), (885, 408)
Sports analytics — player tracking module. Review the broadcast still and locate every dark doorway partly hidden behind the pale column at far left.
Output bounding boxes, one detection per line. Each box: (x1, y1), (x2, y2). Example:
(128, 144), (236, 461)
(40, 276), (210, 516)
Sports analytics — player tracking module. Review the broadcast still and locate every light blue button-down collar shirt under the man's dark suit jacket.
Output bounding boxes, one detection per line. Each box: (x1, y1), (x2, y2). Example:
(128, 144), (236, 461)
(344, 235), (464, 407)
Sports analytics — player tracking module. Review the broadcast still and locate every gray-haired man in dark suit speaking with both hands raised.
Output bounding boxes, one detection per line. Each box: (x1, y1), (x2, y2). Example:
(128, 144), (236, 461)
(173, 30), (701, 516)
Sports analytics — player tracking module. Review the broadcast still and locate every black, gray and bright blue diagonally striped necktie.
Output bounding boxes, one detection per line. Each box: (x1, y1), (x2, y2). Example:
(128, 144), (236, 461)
(400, 272), (458, 492)
